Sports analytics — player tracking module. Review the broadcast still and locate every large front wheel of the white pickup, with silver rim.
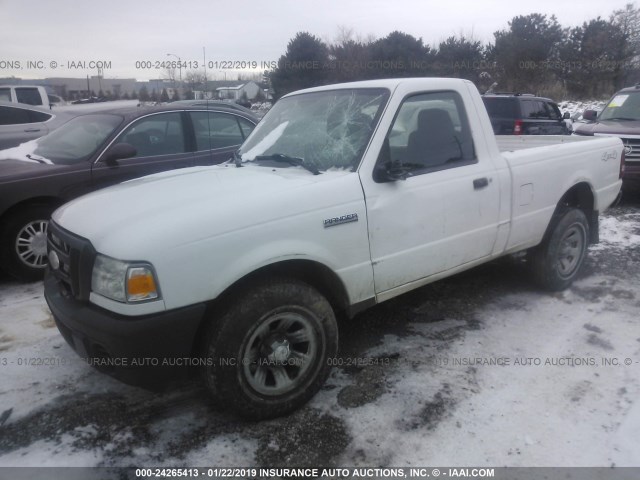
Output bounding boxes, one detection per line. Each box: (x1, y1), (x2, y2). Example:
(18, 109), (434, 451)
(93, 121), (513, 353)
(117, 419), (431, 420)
(203, 279), (338, 419)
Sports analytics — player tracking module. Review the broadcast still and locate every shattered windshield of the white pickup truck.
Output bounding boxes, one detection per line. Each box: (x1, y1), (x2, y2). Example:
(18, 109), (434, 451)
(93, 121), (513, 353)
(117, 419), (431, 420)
(239, 88), (389, 171)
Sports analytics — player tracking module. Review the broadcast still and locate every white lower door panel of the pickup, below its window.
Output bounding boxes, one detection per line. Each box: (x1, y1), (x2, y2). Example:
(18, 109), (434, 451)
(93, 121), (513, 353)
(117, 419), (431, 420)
(367, 159), (500, 293)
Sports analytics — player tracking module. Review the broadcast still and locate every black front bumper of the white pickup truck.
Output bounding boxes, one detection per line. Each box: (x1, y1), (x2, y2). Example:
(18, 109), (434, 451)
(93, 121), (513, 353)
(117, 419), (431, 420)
(44, 273), (206, 386)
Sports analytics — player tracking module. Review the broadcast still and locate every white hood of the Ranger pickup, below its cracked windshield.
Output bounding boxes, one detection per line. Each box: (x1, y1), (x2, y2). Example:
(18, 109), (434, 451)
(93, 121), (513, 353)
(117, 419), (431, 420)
(52, 164), (362, 260)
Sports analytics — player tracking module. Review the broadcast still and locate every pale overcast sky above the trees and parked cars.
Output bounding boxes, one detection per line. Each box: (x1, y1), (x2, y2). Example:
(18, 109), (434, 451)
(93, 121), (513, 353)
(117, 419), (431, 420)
(0, 0), (628, 80)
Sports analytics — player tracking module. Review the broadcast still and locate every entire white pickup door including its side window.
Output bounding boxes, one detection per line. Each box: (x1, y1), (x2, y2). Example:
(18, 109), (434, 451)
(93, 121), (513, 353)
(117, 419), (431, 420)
(362, 88), (500, 294)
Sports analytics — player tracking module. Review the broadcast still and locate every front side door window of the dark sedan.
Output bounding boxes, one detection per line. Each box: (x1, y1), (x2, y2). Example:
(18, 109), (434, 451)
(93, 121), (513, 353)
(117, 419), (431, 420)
(116, 112), (186, 158)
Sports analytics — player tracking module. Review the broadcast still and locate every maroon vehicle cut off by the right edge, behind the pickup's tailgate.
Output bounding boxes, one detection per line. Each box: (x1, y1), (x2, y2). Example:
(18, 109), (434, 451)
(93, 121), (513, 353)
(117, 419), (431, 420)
(573, 84), (640, 188)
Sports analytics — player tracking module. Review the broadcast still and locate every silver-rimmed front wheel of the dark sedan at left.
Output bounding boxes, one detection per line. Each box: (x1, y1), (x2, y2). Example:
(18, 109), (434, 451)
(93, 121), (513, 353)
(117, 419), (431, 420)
(0, 205), (53, 282)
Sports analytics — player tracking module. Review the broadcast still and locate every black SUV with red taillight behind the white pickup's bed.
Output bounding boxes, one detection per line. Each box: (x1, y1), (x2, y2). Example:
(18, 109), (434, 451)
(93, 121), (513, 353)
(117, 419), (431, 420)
(482, 93), (571, 135)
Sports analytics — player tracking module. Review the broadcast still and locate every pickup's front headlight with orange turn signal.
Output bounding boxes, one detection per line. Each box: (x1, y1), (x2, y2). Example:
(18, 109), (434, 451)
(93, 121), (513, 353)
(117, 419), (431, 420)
(91, 255), (159, 303)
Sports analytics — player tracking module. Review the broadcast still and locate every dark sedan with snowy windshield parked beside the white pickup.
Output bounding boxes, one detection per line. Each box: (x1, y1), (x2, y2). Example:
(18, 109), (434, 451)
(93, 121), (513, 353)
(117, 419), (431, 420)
(0, 105), (258, 280)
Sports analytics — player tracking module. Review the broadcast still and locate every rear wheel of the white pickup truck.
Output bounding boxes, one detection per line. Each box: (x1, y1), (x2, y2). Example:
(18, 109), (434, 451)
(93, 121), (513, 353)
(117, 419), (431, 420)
(531, 208), (589, 292)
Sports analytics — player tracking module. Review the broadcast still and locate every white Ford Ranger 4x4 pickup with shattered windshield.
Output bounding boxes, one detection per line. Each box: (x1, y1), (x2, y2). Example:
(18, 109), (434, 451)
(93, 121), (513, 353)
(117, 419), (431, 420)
(45, 78), (624, 417)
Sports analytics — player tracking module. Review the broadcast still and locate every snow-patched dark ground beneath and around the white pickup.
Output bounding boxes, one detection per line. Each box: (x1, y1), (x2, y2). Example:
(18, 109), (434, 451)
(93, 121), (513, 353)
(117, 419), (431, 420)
(0, 203), (640, 467)
